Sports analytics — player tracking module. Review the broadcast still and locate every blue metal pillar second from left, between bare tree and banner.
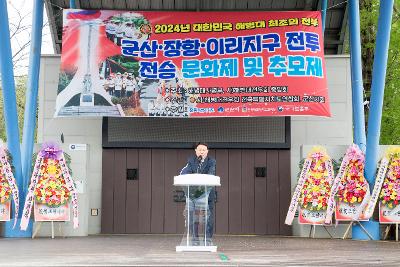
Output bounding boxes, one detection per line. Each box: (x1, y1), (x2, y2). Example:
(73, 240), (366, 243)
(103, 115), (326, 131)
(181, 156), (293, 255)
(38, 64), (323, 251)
(20, 0), (44, 237)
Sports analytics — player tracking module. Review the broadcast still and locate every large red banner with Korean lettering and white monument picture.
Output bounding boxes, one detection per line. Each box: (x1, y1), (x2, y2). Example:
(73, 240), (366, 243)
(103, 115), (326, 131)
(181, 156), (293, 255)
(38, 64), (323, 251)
(55, 9), (330, 117)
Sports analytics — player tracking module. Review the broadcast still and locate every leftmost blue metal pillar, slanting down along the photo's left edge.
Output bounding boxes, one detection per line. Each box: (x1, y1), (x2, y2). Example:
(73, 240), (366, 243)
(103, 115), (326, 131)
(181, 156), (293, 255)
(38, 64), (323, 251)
(0, 0), (31, 237)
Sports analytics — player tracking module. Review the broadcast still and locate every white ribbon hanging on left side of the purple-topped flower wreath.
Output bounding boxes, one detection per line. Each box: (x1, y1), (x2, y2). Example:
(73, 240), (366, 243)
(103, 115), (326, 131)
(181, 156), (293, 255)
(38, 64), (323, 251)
(20, 156), (43, 231)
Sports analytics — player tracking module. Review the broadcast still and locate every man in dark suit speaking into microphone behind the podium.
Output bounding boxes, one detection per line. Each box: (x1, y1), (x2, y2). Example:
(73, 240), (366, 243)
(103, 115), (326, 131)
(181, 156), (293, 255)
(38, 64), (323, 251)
(180, 142), (216, 242)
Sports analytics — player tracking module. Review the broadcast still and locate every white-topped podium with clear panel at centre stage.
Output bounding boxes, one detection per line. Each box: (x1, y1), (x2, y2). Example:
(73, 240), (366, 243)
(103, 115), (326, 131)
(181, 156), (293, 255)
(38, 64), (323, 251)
(174, 174), (221, 252)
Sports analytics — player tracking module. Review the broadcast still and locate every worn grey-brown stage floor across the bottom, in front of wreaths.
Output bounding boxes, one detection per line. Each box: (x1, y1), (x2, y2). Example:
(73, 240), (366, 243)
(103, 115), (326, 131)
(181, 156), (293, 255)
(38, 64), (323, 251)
(0, 235), (400, 266)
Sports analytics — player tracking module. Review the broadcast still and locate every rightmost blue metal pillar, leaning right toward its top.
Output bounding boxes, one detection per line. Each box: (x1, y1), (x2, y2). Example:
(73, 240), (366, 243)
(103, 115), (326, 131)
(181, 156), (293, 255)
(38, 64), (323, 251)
(353, 0), (394, 240)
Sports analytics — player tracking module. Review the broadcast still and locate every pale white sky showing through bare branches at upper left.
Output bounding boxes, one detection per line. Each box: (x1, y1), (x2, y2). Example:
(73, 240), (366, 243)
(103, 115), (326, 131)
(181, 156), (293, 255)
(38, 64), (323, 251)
(7, 0), (54, 75)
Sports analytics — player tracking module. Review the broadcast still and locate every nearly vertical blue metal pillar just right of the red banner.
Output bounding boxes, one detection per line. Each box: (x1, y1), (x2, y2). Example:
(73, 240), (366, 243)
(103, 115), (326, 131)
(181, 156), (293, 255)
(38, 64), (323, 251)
(348, 0), (367, 152)
